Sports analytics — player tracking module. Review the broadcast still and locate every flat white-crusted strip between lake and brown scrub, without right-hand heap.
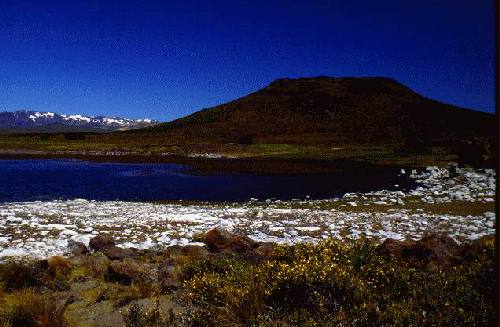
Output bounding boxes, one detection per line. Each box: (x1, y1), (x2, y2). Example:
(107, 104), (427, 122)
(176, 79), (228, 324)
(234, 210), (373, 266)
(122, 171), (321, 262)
(0, 197), (495, 257)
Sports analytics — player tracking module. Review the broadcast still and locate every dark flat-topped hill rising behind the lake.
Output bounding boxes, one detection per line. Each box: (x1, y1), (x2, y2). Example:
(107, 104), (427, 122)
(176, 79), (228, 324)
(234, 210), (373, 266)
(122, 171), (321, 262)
(140, 77), (495, 147)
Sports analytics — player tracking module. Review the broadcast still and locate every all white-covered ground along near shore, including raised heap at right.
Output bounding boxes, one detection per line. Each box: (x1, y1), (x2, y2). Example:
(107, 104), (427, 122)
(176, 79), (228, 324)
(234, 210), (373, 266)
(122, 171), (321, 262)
(0, 167), (496, 260)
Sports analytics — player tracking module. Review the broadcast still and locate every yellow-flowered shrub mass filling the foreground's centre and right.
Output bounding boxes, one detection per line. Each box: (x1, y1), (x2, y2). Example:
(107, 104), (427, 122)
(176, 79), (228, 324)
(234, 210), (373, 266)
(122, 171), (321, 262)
(183, 240), (495, 326)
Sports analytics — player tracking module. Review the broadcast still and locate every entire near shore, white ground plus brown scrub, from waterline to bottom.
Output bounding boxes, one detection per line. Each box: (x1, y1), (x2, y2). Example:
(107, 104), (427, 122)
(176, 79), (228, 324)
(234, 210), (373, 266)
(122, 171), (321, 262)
(0, 160), (496, 327)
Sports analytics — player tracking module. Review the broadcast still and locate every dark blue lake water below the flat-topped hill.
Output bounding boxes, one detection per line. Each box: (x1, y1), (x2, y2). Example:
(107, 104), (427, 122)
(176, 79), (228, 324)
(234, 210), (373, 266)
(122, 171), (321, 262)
(0, 160), (410, 202)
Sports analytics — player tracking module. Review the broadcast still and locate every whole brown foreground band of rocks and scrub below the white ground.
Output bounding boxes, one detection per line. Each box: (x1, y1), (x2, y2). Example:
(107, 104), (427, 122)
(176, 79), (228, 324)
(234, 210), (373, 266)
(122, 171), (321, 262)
(0, 229), (495, 327)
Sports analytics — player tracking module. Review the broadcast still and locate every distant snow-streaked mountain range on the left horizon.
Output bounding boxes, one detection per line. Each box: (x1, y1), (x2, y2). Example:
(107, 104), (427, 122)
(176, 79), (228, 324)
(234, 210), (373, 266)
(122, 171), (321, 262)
(0, 110), (159, 133)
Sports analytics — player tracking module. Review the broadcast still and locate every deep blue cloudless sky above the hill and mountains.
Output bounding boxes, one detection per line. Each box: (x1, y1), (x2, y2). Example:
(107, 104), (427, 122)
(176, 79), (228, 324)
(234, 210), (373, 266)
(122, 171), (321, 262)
(0, 0), (494, 120)
